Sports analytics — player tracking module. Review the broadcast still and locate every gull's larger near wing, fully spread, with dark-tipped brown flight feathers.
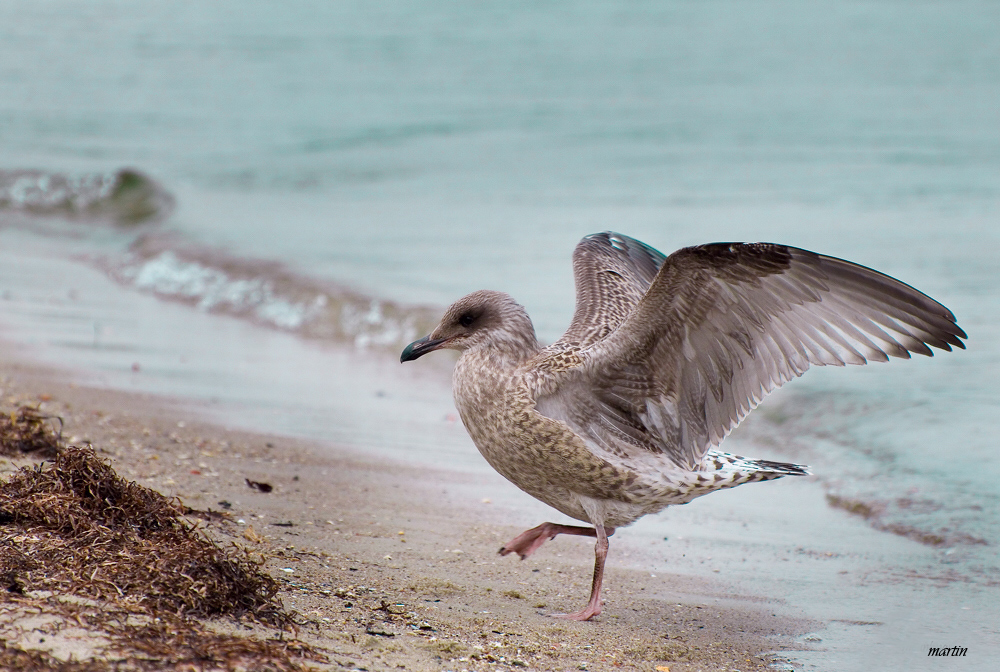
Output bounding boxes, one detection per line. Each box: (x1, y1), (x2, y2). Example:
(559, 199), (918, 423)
(537, 243), (967, 469)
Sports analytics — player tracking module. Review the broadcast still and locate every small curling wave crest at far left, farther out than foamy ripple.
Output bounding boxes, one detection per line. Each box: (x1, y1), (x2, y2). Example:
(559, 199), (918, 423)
(0, 168), (174, 225)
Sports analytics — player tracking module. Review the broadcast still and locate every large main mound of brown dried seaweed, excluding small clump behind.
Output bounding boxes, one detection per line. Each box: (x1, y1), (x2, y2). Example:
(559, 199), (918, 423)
(0, 447), (282, 623)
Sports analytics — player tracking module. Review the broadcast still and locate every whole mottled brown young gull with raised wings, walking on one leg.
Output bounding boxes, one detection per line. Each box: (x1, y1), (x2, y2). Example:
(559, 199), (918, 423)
(400, 232), (968, 621)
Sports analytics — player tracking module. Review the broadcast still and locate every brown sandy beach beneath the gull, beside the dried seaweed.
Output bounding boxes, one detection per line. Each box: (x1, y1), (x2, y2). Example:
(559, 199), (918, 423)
(0, 355), (816, 672)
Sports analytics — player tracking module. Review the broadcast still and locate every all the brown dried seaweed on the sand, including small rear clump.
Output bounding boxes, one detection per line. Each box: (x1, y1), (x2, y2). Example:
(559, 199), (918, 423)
(0, 408), (325, 671)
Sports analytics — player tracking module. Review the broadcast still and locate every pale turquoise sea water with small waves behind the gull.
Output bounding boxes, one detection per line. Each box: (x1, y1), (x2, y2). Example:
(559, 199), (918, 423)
(0, 1), (1000, 669)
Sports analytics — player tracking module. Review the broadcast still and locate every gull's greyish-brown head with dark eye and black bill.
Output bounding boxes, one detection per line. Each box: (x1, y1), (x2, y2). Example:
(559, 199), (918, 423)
(399, 289), (538, 362)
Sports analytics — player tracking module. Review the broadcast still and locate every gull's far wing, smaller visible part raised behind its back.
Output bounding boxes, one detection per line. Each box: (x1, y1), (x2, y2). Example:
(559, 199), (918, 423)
(554, 231), (666, 347)
